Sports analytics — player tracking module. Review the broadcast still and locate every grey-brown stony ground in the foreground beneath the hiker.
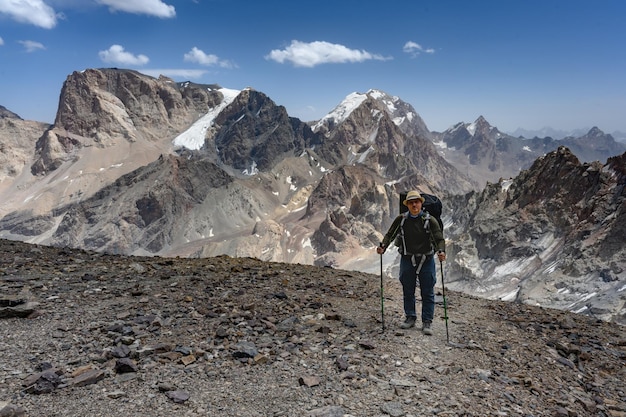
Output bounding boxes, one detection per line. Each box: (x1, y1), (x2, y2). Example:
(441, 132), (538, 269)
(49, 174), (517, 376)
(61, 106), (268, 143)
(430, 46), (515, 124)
(0, 240), (626, 417)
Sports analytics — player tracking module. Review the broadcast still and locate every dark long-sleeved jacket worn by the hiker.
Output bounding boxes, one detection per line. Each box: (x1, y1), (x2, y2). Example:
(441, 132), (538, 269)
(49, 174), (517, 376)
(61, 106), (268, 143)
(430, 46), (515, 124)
(382, 211), (446, 255)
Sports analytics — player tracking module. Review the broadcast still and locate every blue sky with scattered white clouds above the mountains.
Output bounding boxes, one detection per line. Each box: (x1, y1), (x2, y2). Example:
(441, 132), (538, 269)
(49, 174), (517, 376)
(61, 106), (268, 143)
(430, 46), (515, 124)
(0, 0), (626, 133)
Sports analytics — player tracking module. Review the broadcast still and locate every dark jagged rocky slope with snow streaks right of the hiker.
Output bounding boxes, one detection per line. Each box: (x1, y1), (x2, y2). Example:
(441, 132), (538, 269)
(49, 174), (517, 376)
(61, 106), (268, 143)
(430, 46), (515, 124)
(448, 147), (626, 324)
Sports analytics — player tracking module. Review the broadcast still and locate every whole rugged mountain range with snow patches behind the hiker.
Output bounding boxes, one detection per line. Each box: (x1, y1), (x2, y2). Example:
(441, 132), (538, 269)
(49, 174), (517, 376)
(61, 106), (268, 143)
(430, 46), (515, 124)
(0, 68), (626, 324)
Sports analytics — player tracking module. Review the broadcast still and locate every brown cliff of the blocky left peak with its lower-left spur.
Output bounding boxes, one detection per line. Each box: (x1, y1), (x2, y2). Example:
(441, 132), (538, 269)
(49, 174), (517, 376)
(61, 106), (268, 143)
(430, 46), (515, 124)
(32, 69), (222, 175)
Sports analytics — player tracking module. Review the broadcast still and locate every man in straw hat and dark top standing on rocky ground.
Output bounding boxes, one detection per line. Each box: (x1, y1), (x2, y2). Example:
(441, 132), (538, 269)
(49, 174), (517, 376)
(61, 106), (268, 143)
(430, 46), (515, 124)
(376, 191), (446, 335)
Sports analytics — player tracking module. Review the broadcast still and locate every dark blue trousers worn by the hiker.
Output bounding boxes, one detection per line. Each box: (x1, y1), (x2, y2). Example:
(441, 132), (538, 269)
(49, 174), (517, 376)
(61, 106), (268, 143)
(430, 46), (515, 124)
(400, 255), (437, 322)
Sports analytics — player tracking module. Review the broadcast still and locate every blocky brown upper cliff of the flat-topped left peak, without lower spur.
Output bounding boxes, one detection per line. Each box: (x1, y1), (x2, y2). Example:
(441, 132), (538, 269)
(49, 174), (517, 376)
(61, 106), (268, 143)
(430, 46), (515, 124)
(55, 69), (210, 140)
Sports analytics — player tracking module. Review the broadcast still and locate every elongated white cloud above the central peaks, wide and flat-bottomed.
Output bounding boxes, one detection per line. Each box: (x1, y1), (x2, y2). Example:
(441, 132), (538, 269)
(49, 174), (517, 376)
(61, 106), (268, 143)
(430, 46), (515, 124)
(265, 40), (391, 67)
